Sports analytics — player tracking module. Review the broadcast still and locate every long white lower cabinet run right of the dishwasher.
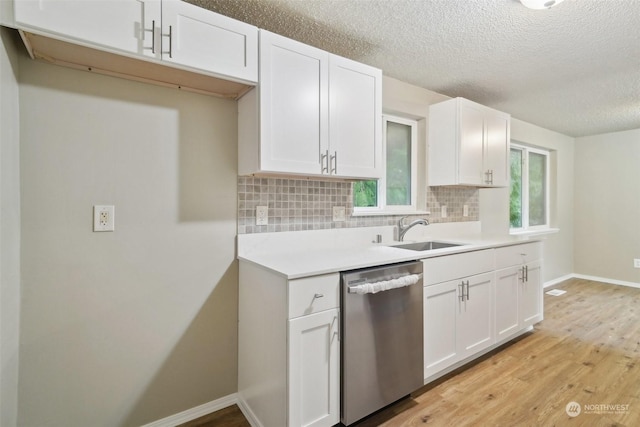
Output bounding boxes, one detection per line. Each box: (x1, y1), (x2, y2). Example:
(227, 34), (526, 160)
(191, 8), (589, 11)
(423, 242), (543, 383)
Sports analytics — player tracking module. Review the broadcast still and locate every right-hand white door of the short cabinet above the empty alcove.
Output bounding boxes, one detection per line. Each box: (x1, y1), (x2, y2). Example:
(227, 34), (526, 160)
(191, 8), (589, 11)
(161, 0), (258, 82)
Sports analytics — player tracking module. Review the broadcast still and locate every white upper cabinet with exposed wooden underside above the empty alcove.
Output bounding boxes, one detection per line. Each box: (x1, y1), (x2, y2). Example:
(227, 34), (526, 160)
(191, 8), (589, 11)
(8, 0), (258, 98)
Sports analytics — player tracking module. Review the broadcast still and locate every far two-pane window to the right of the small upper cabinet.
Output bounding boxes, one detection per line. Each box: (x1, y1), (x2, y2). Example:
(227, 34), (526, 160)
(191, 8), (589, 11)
(509, 144), (549, 231)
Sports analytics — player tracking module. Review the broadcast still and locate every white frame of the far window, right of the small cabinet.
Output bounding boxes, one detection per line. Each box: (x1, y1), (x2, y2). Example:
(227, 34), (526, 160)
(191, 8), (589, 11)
(509, 141), (551, 234)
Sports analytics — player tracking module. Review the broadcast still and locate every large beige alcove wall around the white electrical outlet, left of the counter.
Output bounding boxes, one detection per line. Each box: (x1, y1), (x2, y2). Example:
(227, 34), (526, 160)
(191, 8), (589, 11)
(16, 53), (238, 427)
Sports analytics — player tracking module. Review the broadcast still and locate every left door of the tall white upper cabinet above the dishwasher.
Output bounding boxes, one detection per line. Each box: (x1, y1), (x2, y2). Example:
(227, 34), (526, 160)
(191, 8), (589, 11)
(259, 30), (329, 175)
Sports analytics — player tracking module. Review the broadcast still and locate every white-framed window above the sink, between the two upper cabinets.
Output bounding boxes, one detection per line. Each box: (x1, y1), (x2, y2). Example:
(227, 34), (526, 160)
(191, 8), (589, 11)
(353, 116), (418, 213)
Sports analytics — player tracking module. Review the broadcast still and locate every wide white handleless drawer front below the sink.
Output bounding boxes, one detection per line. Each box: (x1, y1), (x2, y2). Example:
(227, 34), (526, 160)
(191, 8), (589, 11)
(423, 249), (495, 286)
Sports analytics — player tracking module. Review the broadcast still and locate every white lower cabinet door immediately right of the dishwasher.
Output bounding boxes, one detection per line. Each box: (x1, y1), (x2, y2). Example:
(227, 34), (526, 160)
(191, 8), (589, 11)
(423, 281), (460, 379)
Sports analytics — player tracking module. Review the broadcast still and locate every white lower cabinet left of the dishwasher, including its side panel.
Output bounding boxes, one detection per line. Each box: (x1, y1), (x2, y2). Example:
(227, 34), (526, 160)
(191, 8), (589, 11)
(238, 262), (340, 427)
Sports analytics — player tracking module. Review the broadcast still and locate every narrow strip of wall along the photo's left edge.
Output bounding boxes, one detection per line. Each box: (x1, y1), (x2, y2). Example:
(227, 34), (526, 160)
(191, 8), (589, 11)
(0, 28), (20, 427)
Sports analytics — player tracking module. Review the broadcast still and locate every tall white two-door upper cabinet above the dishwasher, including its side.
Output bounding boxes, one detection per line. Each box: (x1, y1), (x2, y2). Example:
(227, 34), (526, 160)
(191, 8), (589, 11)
(238, 30), (382, 178)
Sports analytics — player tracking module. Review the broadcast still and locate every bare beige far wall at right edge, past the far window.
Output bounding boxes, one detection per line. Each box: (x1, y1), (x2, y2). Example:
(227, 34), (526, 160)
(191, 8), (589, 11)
(575, 129), (640, 285)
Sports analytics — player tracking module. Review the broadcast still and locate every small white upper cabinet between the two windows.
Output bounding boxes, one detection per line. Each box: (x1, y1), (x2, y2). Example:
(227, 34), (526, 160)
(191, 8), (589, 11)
(429, 98), (511, 187)
